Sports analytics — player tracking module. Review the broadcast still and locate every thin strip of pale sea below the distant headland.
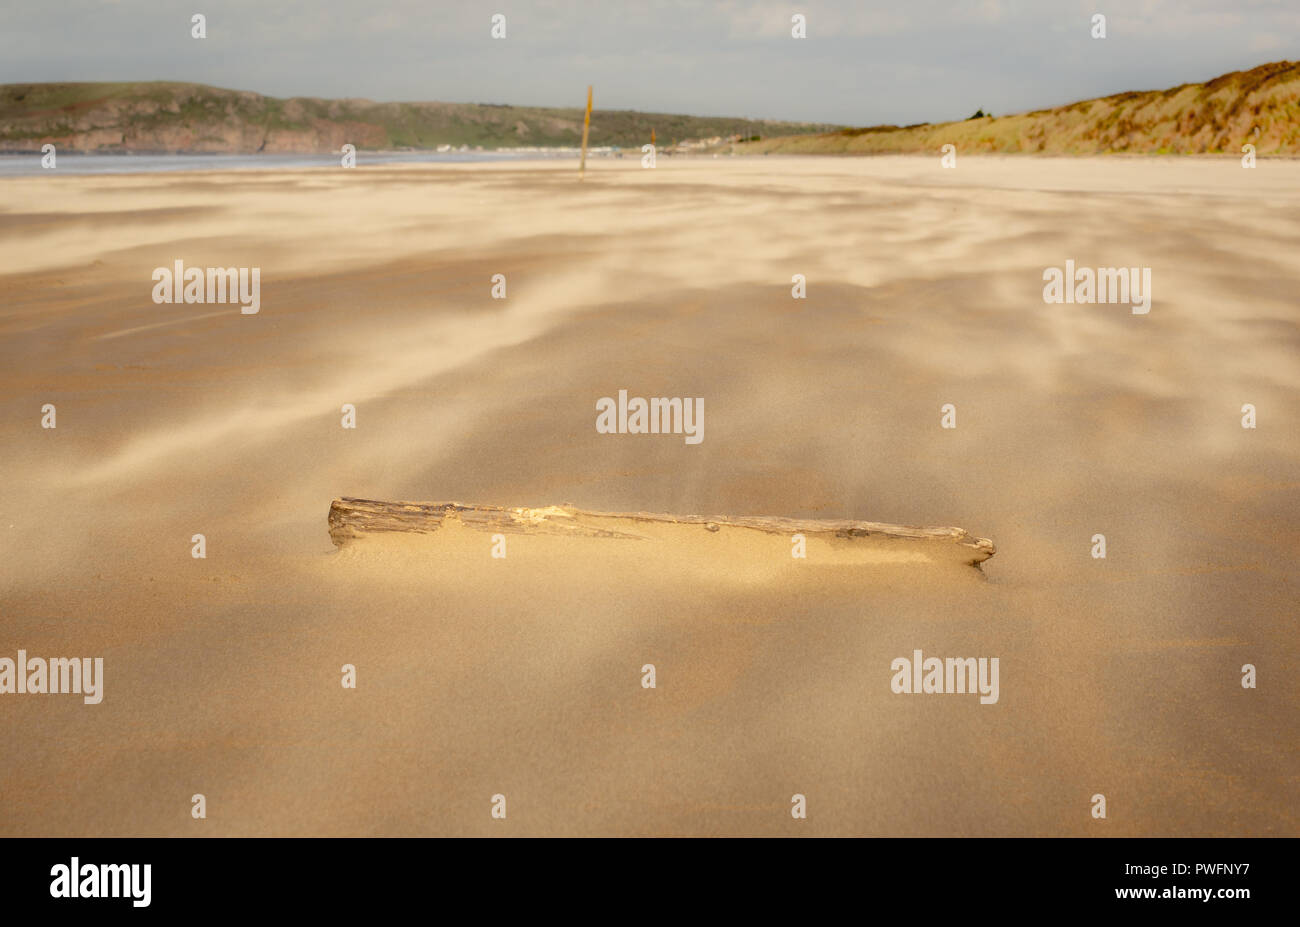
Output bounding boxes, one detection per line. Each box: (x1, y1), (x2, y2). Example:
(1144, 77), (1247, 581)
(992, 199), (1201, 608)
(0, 148), (577, 177)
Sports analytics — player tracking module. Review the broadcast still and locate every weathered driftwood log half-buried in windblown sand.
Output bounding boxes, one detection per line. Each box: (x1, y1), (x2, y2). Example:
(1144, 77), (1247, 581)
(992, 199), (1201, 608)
(329, 498), (995, 564)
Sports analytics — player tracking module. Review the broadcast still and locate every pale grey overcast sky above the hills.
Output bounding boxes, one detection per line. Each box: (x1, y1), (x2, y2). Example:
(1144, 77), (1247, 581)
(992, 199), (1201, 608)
(0, 0), (1300, 125)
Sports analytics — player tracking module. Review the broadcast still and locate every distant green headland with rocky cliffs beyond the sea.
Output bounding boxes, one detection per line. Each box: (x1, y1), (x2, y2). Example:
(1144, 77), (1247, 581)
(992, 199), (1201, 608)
(0, 82), (836, 152)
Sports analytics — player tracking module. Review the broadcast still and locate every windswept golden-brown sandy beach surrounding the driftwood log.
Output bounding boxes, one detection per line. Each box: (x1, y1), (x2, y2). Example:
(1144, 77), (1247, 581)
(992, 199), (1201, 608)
(0, 157), (1300, 835)
